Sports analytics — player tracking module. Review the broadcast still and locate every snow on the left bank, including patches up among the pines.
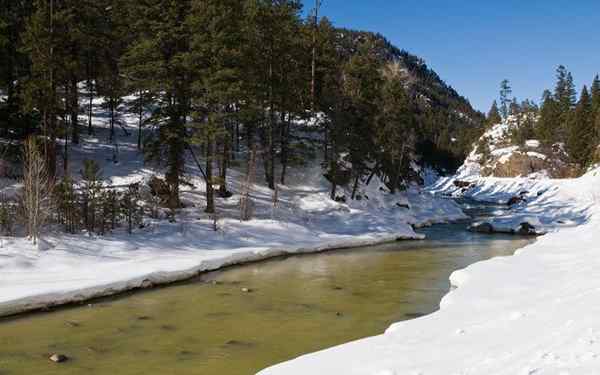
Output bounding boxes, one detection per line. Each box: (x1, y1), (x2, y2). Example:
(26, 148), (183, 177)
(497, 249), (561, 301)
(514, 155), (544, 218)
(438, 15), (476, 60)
(0, 95), (466, 316)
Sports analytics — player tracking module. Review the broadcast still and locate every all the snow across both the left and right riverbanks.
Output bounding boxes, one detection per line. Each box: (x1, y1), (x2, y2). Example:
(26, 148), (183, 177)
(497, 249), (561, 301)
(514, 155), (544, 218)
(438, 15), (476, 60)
(5, 92), (600, 375)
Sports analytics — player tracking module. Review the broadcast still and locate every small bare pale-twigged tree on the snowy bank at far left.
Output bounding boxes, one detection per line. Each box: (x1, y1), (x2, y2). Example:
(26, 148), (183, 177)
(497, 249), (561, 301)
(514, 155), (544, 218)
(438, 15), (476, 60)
(21, 137), (51, 244)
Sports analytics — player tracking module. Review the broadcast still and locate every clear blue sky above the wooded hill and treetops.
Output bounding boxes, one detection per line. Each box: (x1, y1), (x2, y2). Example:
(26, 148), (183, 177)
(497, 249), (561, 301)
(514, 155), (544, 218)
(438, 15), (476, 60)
(304, 0), (600, 111)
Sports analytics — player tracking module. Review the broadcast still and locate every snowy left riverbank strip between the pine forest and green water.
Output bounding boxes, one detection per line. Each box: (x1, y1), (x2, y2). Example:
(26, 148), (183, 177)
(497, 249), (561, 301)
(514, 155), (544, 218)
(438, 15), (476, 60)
(0, 178), (465, 316)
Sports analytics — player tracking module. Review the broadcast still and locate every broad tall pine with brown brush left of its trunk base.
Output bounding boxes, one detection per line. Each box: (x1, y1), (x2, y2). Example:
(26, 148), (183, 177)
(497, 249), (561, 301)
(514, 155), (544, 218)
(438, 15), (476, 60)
(121, 0), (190, 212)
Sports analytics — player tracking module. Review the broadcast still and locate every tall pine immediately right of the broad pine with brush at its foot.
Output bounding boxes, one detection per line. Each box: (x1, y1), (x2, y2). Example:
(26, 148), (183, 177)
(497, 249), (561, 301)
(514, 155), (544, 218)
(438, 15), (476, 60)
(187, 0), (247, 213)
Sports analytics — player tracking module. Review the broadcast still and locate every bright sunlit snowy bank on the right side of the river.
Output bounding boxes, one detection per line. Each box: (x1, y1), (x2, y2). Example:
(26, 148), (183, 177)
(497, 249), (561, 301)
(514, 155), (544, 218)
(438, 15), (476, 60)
(260, 170), (600, 375)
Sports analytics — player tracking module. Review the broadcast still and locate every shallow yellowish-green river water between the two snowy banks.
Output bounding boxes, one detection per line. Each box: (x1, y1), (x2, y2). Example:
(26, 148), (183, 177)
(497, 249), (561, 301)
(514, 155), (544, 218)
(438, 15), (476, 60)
(0, 203), (531, 375)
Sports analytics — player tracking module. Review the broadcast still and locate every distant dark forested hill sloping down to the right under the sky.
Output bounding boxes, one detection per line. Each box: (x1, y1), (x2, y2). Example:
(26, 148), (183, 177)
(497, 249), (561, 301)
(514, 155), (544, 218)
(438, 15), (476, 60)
(338, 28), (485, 172)
